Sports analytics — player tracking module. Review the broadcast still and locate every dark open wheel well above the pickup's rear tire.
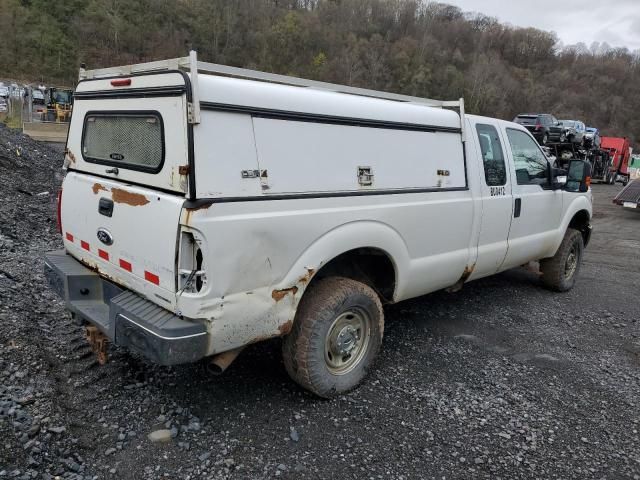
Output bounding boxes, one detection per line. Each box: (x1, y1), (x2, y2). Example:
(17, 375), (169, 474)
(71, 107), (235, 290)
(312, 248), (396, 303)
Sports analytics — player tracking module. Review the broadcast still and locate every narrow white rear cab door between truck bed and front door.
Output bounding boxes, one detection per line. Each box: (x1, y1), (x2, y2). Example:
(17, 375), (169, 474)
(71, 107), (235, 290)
(471, 119), (513, 279)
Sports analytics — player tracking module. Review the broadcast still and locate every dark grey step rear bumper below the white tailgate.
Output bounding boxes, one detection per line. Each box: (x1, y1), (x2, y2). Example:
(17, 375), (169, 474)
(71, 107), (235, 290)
(44, 250), (209, 365)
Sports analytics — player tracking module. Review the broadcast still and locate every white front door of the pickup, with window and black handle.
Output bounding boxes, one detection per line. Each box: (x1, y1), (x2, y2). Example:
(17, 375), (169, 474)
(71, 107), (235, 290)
(502, 127), (562, 270)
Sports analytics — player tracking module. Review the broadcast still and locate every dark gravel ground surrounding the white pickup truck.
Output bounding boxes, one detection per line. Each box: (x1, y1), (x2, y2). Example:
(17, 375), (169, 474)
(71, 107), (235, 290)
(0, 126), (640, 479)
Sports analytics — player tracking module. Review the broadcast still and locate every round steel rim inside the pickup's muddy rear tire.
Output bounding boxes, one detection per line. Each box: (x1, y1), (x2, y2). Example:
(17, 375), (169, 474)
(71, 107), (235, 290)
(324, 308), (371, 375)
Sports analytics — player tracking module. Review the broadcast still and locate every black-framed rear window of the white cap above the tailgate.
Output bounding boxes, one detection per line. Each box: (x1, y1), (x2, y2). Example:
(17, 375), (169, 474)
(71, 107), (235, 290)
(82, 112), (164, 173)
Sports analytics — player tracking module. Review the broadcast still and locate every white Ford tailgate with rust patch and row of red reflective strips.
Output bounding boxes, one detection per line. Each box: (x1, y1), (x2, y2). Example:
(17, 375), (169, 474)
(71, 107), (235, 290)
(60, 172), (184, 310)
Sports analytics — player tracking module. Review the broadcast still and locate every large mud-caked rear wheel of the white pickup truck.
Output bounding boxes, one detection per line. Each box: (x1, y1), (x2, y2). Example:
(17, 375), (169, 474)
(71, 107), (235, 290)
(282, 277), (384, 398)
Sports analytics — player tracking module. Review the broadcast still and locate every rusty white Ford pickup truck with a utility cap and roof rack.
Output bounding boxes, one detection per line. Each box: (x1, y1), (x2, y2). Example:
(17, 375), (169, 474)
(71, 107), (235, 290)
(45, 52), (592, 397)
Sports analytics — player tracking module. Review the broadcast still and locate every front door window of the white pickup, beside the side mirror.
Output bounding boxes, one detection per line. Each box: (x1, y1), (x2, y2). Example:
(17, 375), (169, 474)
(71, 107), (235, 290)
(507, 128), (549, 185)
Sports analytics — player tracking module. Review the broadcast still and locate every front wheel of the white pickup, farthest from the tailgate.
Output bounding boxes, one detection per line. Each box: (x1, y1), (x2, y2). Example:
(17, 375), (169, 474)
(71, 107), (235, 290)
(540, 228), (584, 292)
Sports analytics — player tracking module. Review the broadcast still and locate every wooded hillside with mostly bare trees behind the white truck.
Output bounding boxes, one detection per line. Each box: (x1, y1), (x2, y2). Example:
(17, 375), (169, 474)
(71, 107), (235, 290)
(0, 0), (640, 144)
